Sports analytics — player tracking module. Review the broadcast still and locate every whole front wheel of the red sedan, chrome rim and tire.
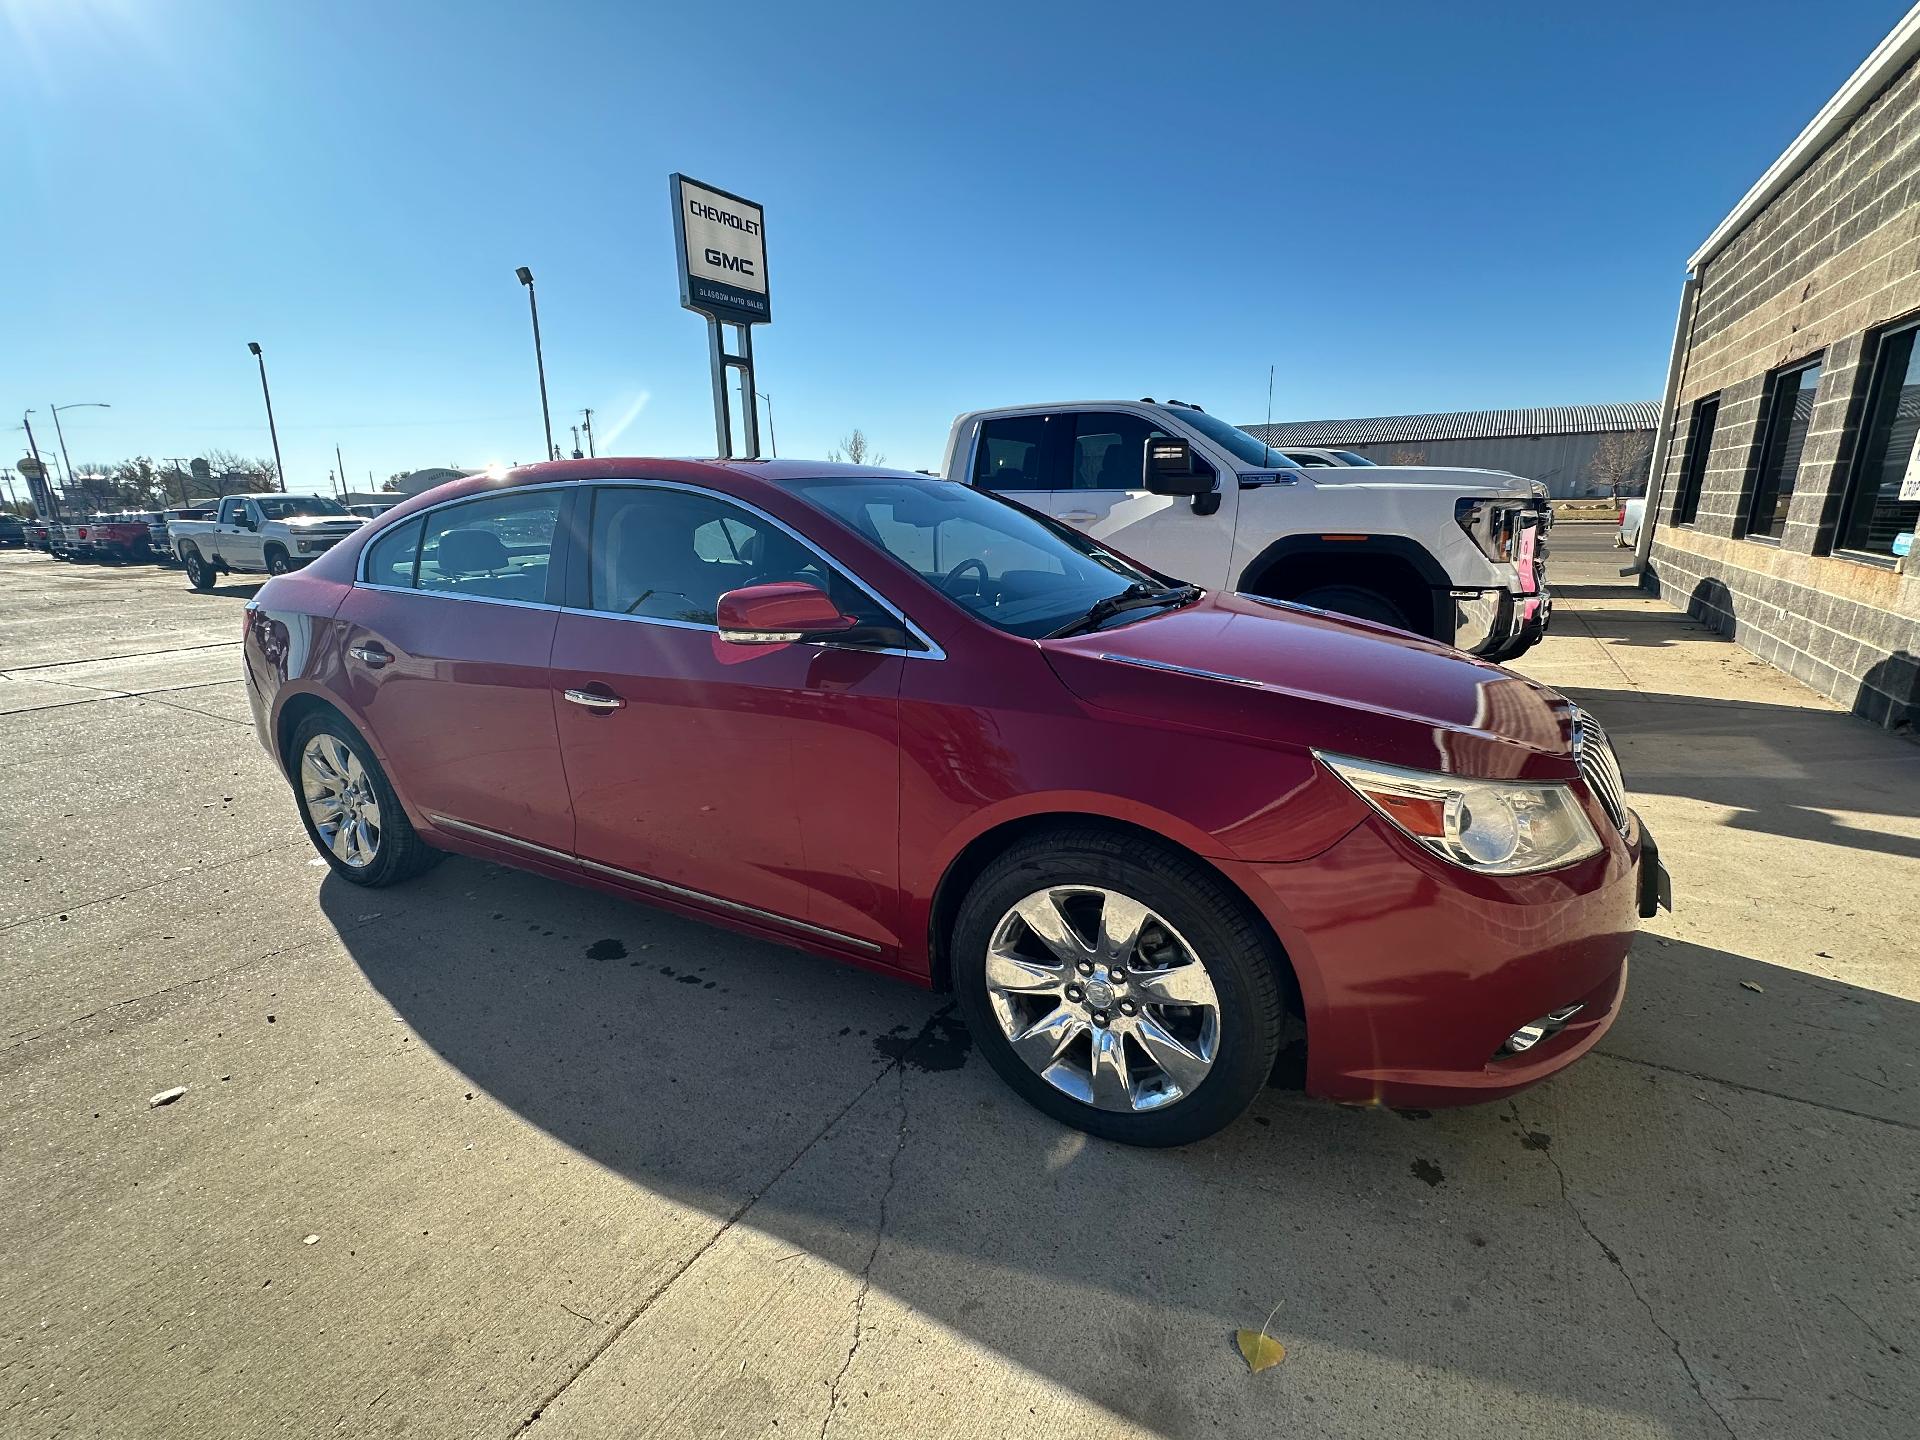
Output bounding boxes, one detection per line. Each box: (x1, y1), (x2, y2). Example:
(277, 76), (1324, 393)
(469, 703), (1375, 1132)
(952, 828), (1284, 1146)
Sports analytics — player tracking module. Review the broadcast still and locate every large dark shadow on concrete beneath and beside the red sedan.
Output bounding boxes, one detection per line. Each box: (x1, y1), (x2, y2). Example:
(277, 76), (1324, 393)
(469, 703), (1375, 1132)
(321, 856), (1920, 1434)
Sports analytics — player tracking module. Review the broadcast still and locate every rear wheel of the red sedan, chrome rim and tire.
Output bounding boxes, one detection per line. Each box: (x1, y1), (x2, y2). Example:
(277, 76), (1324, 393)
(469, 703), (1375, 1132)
(288, 710), (442, 889)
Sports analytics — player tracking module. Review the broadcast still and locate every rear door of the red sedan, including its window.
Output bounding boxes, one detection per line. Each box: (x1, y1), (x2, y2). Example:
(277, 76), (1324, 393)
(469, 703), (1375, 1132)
(336, 486), (574, 854)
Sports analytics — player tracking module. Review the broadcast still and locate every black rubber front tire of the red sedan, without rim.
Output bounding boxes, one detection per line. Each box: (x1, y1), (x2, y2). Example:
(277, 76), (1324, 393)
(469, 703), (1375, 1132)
(952, 826), (1286, 1146)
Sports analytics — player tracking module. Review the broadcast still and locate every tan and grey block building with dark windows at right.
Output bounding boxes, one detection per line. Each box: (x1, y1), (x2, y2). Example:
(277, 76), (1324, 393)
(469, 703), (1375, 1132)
(1644, 6), (1920, 726)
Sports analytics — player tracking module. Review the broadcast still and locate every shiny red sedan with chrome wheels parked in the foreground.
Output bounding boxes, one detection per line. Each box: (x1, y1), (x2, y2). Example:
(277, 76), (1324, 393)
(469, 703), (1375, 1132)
(246, 459), (1663, 1144)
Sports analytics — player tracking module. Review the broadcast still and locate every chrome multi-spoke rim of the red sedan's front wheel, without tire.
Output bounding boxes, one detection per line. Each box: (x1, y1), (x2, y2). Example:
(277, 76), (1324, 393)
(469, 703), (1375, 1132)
(987, 885), (1219, 1114)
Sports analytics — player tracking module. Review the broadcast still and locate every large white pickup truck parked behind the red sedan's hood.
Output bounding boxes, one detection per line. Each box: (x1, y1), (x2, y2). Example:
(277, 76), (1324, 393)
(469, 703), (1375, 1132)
(943, 399), (1553, 660)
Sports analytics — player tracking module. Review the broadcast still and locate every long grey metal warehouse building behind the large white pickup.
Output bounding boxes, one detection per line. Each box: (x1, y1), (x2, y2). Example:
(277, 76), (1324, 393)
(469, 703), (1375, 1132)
(1242, 399), (1661, 499)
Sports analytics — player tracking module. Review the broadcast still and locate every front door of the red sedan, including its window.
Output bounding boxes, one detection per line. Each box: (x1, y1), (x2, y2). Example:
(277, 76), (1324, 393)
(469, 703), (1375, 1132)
(553, 482), (904, 950)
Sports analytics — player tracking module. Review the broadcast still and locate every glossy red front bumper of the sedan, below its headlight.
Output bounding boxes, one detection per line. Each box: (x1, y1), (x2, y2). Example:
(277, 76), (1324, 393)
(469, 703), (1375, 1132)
(1223, 820), (1665, 1106)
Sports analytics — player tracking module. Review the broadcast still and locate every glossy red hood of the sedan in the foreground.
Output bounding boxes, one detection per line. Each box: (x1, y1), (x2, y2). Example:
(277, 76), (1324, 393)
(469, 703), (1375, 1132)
(1041, 593), (1572, 780)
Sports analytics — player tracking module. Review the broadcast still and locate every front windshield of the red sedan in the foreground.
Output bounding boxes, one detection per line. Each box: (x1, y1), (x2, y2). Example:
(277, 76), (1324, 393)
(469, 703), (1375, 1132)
(793, 476), (1160, 639)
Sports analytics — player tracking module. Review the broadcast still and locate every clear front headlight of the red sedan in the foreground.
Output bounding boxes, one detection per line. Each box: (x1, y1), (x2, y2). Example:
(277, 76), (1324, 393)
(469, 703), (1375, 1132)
(1313, 751), (1599, 876)
